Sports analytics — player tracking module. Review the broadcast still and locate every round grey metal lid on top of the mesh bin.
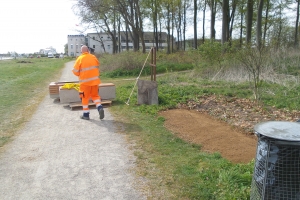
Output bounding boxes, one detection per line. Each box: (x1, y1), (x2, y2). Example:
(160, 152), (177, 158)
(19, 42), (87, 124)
(254, 121), (300, 142)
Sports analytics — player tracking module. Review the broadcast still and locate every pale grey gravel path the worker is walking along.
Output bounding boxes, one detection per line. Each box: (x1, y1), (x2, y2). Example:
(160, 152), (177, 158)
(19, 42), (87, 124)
(0, 62), (146, 200)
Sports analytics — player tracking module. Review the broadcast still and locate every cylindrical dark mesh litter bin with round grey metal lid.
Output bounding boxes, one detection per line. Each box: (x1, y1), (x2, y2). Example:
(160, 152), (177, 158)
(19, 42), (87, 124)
(250, 121), (300, 200)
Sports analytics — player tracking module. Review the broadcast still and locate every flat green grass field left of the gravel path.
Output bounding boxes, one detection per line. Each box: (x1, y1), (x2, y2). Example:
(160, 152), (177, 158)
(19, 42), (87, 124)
(0, 58), (72, 146)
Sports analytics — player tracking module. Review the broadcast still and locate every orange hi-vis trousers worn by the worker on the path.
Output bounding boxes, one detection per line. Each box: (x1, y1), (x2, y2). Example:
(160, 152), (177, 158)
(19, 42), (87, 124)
(79, 84), (101, 113)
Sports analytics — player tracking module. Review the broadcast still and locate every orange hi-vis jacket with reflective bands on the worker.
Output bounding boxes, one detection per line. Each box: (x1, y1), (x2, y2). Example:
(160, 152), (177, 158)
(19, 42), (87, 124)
(72, 52), (101, 86)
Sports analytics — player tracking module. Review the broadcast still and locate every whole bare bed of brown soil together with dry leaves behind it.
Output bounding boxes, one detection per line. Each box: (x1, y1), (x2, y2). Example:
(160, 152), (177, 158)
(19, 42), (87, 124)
(160, 95), (300, 163)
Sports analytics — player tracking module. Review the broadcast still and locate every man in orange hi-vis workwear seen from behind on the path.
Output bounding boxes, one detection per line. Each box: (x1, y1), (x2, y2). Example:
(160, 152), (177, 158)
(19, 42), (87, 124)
(72, 45), (104, 120)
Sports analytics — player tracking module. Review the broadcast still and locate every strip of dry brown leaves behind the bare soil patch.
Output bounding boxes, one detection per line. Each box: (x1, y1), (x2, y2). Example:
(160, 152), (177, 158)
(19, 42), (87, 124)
(178, 95), (300, 134)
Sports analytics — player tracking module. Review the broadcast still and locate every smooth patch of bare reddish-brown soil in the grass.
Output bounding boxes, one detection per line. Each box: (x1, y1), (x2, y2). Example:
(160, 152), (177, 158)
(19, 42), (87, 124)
(160, 109), (257, 163)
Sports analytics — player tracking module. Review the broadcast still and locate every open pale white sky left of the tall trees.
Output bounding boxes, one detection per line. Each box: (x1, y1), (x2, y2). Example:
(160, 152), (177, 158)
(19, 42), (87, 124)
(0, 0), (79, 54)
